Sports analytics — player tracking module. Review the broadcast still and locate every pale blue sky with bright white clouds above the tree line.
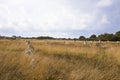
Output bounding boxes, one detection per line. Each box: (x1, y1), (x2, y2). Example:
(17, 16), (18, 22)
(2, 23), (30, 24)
(0, 0), (120, 38)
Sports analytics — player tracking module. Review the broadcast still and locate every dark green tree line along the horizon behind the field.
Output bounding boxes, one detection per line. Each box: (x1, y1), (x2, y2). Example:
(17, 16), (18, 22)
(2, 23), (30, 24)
(0, 31), (120, 41)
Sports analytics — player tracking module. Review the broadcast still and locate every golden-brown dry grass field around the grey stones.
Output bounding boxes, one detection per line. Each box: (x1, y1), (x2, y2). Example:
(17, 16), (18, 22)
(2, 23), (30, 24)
(0, 39), (120, 80)
